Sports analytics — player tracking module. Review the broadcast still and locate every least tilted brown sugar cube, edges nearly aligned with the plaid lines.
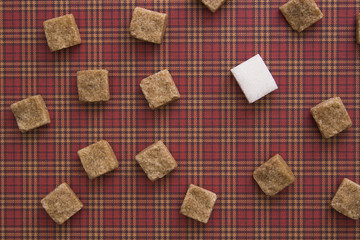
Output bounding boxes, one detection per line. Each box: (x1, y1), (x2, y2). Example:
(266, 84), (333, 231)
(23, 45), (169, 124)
(77, 70), (110, 102)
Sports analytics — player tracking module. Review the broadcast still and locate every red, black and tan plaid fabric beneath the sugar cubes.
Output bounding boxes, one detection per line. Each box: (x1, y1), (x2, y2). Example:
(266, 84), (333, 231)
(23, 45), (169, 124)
(0, 0), (360, 239)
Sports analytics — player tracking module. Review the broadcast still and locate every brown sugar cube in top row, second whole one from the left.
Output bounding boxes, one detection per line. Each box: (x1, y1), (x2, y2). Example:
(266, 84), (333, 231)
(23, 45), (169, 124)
(130, 7), (167, 44)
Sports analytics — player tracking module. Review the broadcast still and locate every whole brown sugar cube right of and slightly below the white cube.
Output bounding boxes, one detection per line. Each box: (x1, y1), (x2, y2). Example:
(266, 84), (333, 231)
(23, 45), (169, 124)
(310, 97), (352, 138)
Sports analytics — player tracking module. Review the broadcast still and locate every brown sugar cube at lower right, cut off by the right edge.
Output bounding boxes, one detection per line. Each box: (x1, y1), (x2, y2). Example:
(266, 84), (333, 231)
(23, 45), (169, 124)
(331, 178), (360, 220)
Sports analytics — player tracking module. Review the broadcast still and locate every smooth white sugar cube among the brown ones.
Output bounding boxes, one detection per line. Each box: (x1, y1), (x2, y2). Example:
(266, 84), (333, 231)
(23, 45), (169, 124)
(231, 54), (278, 103)
